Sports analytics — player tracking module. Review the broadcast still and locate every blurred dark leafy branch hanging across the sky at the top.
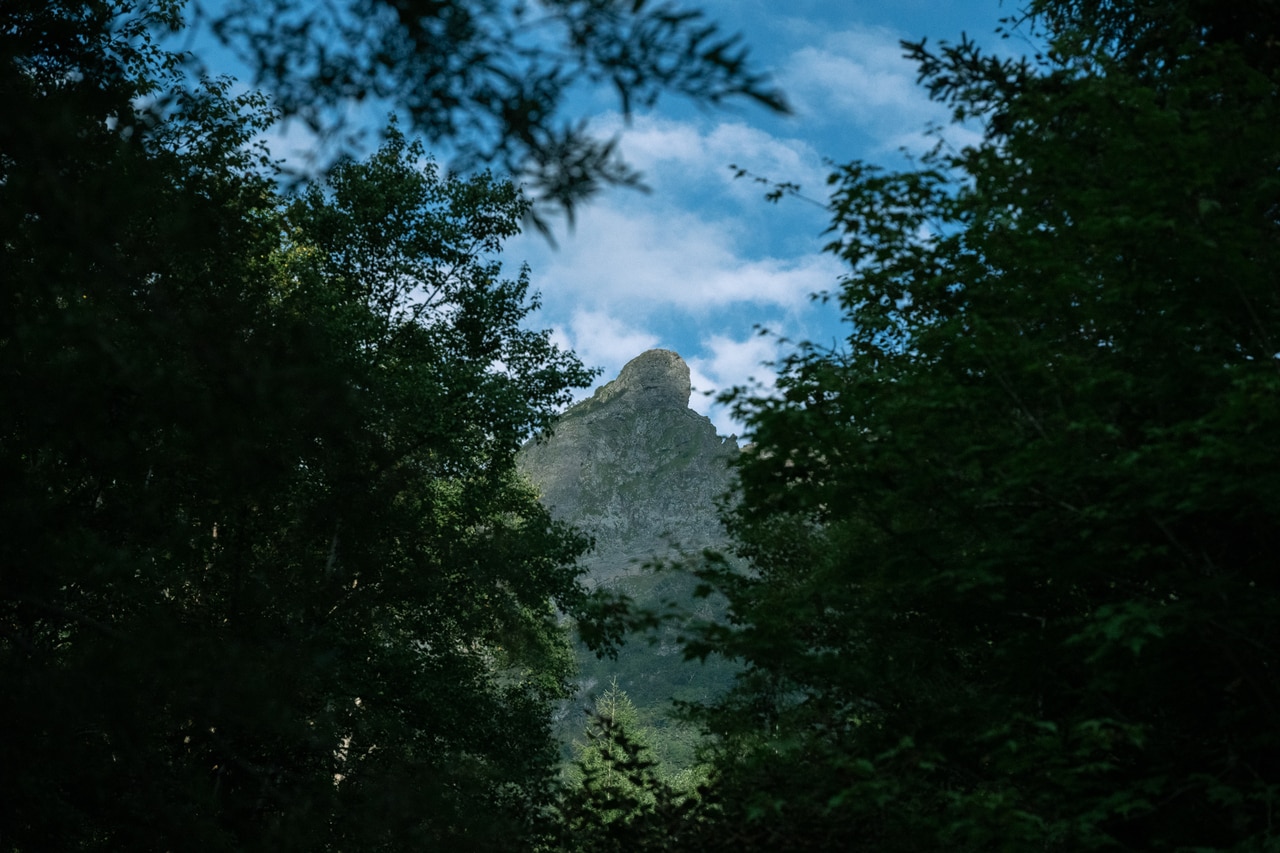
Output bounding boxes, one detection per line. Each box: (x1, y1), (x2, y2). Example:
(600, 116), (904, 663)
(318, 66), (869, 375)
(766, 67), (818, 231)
(196, 0), (786, 222)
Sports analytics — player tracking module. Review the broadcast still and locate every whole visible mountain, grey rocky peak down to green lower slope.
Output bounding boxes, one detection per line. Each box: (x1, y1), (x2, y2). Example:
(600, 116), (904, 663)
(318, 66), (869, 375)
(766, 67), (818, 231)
(518, 350), (739, 770)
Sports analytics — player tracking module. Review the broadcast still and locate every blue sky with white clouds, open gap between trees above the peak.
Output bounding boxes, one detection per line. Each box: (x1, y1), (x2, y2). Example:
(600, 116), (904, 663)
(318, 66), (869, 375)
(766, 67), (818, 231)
(212, 0), (1025, 434)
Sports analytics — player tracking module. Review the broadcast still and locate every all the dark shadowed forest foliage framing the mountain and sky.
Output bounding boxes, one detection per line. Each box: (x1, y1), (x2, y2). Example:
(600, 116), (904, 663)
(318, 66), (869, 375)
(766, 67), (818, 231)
(0, 0), (1280, 853)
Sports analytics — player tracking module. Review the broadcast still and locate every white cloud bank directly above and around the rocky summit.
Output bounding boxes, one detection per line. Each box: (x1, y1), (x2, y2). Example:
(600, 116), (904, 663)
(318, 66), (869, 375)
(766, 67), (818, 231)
(507, 108), (842, 434)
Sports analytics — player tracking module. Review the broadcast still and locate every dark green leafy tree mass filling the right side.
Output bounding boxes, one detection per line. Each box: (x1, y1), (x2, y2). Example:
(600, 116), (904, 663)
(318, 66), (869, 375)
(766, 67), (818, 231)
(690, 0), (1280, 850)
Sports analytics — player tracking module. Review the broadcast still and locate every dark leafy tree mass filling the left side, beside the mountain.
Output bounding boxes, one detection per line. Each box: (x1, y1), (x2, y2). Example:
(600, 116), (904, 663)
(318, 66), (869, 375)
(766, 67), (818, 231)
(0, 8), (601, 850)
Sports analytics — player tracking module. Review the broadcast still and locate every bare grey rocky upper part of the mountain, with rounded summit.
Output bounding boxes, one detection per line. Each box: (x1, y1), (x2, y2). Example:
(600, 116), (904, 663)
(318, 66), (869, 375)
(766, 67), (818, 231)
(520, 350), (737, 583)
